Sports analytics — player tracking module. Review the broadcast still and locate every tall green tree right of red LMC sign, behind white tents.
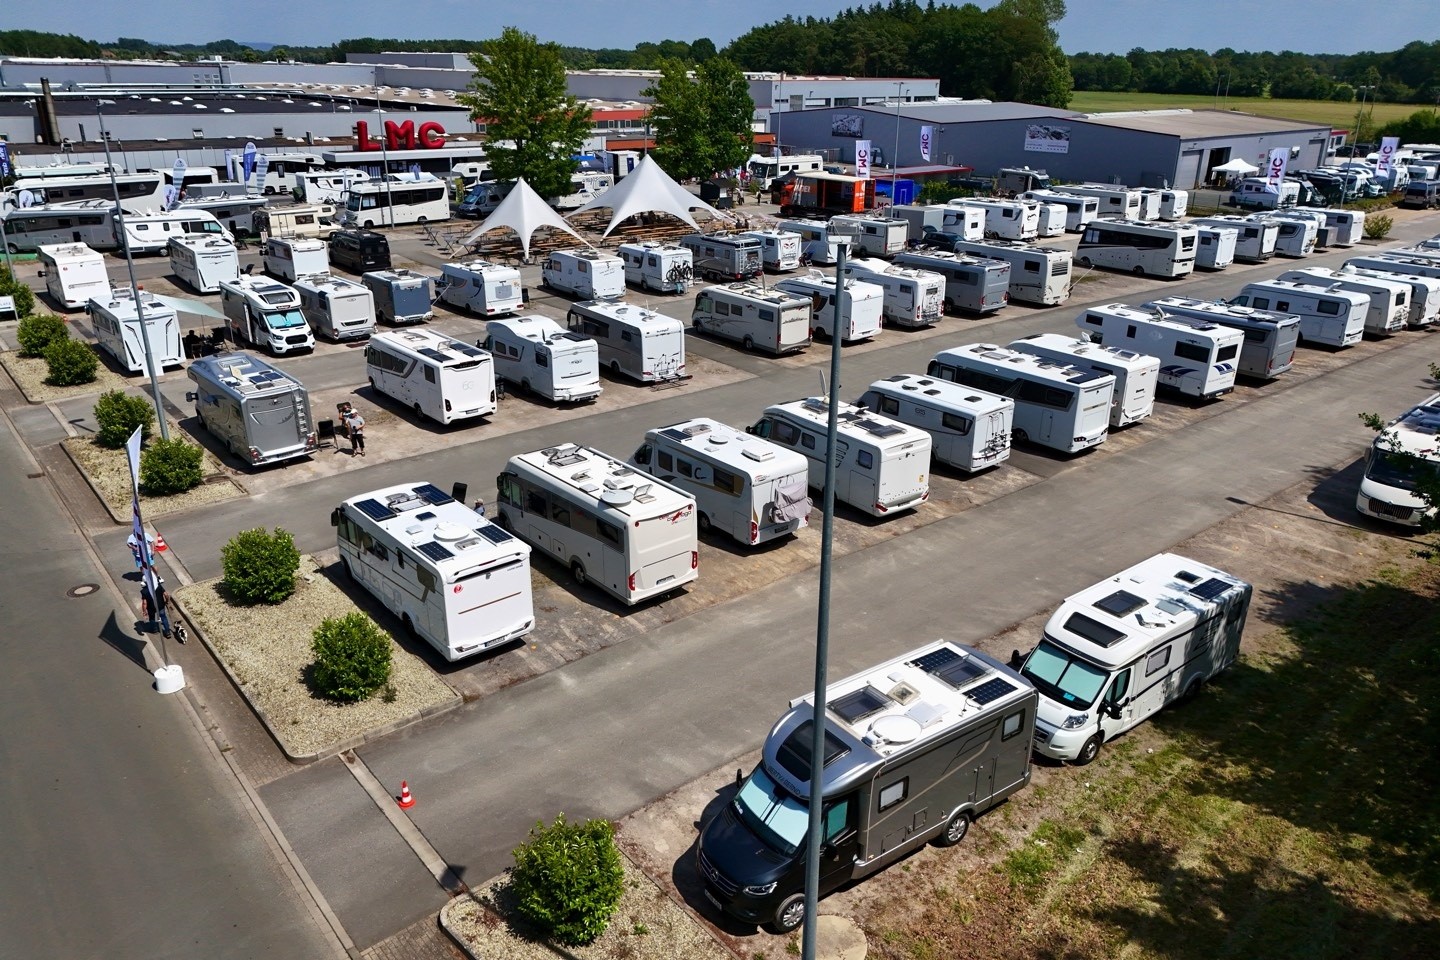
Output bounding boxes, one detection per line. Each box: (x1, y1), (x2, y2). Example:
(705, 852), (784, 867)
(456, 27), (590, 197)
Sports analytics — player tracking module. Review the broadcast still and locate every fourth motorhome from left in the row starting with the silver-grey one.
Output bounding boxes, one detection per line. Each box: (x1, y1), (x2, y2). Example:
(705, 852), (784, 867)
(566, 299), (688, 383)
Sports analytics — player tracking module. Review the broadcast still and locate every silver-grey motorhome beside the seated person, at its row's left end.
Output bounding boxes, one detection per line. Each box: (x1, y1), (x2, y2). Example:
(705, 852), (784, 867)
(186, 353), (317, 466)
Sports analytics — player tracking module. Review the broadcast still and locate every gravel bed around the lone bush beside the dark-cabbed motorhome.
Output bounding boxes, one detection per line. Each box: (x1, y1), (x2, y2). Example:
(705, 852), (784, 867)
(441, 853), (733, 960)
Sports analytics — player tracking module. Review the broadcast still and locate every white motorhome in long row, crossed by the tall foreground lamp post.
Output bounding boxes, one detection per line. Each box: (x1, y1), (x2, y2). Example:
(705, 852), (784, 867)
(746, 397), (930, 517)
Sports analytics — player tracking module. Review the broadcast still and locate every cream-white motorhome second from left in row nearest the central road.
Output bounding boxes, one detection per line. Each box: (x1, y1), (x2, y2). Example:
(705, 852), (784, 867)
(495, 443), (700, 606)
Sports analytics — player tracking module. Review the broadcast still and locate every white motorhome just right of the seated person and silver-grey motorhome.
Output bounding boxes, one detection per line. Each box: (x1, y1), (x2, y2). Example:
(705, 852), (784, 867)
(364, 328), (498, 423)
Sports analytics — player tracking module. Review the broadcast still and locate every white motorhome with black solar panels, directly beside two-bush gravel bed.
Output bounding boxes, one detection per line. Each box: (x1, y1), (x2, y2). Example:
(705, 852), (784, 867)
(330, 481), (536, 664)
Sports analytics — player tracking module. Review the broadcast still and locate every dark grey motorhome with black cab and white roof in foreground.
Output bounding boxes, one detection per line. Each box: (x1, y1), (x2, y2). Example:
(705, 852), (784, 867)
(696, 640), (1037, 934)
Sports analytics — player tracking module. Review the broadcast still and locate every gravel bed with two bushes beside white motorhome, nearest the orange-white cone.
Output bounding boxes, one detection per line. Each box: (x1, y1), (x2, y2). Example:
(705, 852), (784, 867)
(174, 556), (456, 757)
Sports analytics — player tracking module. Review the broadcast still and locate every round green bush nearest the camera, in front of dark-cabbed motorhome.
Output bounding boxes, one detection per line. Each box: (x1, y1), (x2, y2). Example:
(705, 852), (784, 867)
(510, 813), (625, 946)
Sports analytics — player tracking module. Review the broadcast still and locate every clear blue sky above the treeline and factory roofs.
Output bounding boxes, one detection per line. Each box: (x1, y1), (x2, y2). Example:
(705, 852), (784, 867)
(0, 0), (1440, 53)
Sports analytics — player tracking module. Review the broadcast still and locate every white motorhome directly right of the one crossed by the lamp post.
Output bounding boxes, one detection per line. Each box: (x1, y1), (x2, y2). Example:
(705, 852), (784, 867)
(855, 373), (1015, 474)
